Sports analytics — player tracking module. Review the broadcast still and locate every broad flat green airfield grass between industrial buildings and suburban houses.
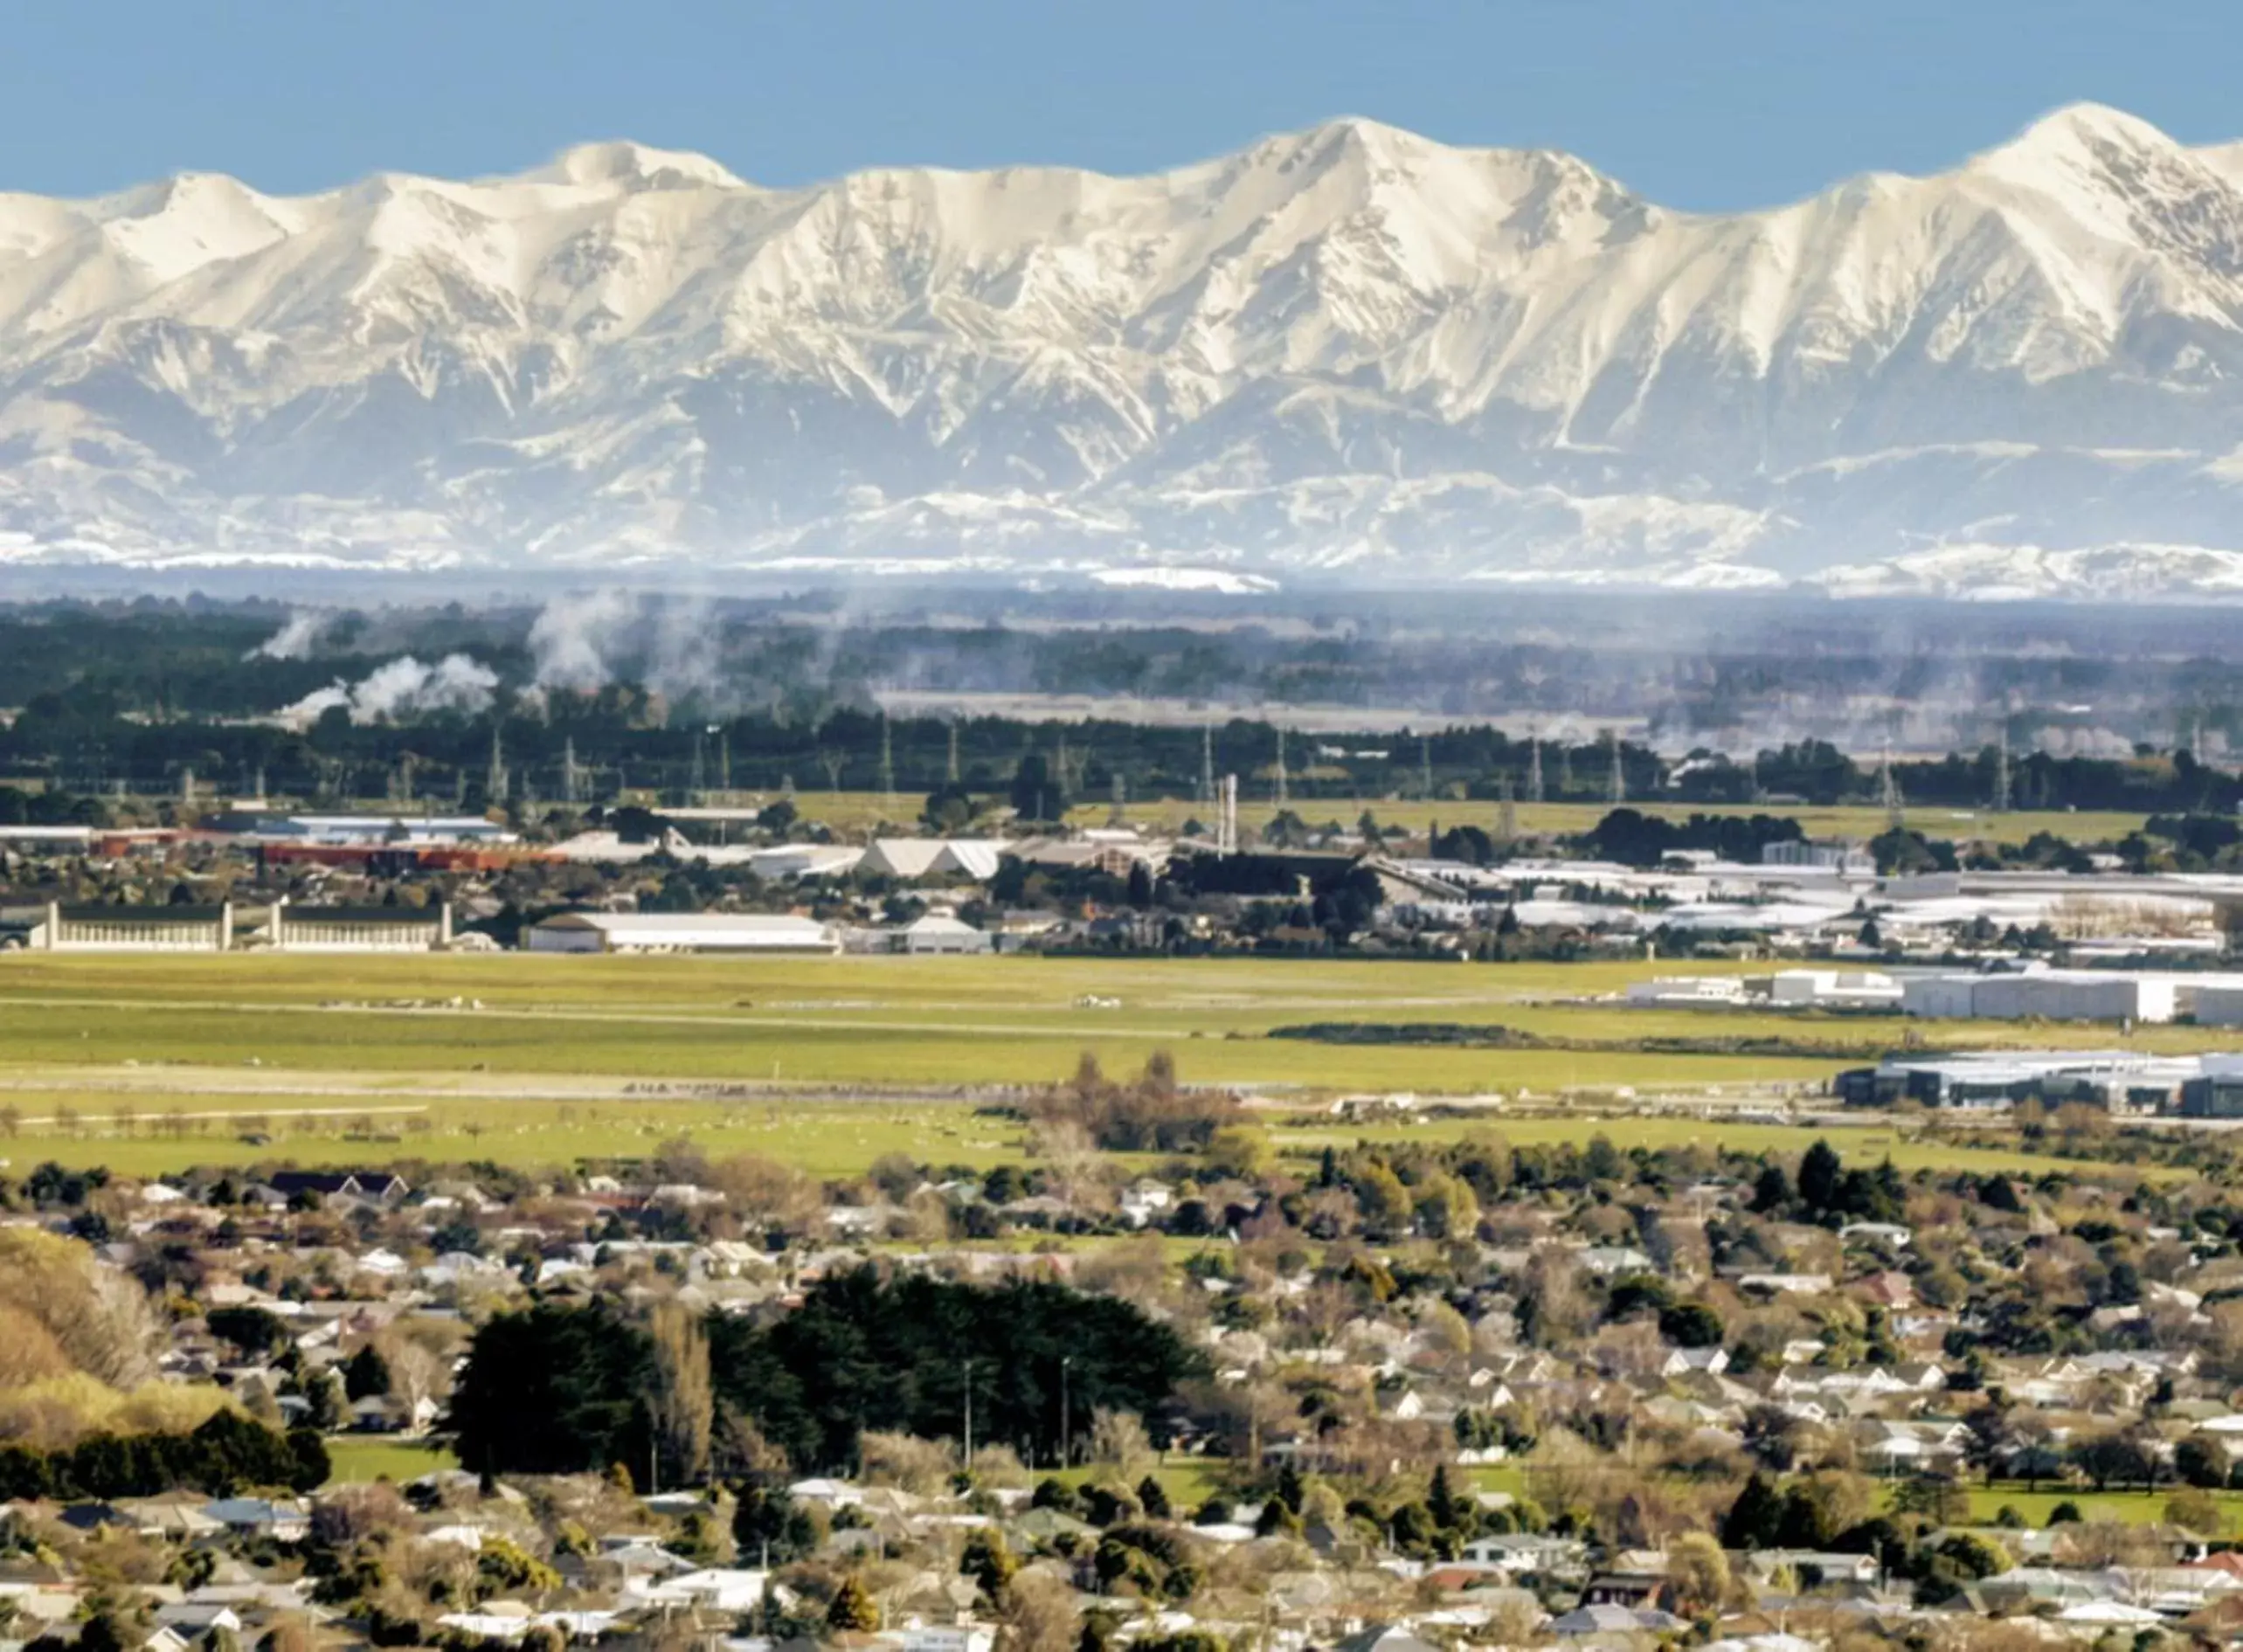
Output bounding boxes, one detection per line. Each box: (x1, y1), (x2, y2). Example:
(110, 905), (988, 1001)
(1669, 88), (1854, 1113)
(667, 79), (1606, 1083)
(0, 952), (2198, 1177)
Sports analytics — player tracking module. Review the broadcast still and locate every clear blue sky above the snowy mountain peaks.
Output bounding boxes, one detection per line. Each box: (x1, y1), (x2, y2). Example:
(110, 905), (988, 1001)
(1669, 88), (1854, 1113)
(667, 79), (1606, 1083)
(0, 0), (2243, 211)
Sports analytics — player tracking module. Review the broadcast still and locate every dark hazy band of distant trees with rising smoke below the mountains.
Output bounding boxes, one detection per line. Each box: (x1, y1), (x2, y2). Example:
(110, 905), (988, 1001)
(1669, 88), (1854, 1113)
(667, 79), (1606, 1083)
(0, 601), (2243, 823)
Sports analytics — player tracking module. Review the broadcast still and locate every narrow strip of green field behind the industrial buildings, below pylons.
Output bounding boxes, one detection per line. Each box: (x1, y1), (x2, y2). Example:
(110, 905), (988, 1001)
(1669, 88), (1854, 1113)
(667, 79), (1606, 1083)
(749, 776), (2144, 843)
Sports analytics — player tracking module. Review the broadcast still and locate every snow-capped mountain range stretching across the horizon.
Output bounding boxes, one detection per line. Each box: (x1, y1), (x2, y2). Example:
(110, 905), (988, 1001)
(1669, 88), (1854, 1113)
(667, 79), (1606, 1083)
(0, 106), (2243, 597)
